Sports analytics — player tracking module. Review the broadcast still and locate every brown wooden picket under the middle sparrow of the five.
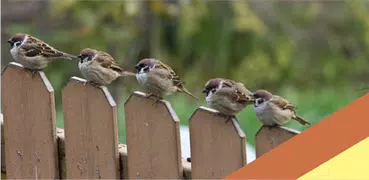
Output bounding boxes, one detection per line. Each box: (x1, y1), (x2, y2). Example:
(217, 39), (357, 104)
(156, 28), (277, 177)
(125, 92), (183, 179)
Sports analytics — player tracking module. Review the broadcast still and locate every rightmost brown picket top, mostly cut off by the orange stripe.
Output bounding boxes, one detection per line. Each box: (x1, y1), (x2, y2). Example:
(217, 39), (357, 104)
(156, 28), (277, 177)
(255, 126), (300, 158)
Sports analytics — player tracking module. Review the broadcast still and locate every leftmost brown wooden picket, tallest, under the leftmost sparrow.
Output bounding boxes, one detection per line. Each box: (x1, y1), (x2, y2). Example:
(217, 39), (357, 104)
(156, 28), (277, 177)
(1, 62), (58, 179)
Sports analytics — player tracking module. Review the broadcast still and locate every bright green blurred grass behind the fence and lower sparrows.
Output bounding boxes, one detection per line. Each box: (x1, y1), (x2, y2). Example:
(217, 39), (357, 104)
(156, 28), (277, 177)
(57, 88), (360, 145)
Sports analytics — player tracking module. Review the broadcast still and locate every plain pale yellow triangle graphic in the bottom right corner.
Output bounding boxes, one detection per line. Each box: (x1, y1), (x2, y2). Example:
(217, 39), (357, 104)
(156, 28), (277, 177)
(299, 137), (369, 180)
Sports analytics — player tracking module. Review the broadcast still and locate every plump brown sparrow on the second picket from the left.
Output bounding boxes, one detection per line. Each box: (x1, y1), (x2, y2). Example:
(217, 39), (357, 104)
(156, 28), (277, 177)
(77, 48), (136, 86)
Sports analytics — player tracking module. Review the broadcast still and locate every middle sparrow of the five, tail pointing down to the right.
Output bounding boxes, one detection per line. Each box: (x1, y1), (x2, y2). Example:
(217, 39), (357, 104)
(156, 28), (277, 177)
(135, 58), (198, 100)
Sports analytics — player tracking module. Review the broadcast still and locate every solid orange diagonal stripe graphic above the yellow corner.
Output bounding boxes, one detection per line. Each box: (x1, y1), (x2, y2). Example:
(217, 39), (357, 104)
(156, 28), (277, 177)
(225, 93), (369, 180)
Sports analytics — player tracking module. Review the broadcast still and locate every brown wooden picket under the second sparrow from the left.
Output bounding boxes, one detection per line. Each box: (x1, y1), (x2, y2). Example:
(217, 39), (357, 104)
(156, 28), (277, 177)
(62, 77), (119, 179)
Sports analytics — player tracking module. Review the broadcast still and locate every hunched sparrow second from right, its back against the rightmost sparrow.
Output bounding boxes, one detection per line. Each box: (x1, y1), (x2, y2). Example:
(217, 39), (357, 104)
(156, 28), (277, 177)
(202, 78), (254, 117)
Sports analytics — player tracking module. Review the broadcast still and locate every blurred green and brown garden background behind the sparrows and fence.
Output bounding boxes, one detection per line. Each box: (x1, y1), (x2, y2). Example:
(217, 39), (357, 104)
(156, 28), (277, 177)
(0, 0), (369, 144)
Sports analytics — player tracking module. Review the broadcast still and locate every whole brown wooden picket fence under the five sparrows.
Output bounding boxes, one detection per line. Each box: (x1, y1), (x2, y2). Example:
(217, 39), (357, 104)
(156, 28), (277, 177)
(0, 63), (299, 179)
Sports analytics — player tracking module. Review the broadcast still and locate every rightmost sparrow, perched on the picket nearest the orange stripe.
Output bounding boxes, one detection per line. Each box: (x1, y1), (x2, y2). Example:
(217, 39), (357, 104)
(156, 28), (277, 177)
(253, 89), (311, 126)
